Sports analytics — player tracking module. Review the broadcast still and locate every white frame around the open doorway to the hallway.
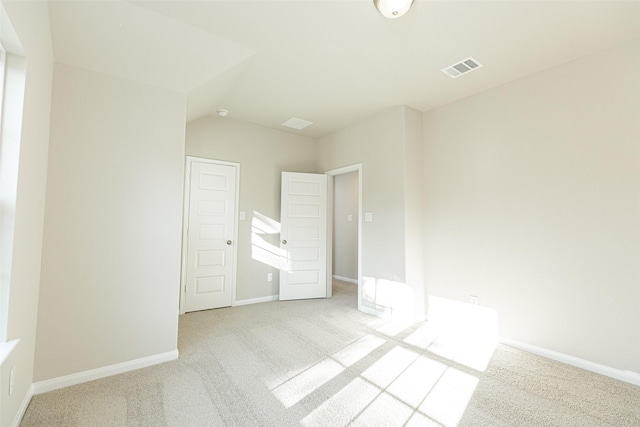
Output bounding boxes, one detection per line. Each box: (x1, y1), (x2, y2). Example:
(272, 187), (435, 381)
(325, 163), (362, 311)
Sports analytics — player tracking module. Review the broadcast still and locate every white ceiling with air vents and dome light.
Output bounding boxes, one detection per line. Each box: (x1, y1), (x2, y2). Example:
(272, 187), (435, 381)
(49, 0), (640, 138)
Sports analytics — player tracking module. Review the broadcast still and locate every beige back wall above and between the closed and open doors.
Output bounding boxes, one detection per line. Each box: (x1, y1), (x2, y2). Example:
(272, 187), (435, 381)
(186, 117), (318, 301)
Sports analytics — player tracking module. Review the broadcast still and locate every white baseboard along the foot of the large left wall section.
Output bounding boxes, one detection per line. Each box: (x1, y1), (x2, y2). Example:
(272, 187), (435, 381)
(33, 349), (178, 394)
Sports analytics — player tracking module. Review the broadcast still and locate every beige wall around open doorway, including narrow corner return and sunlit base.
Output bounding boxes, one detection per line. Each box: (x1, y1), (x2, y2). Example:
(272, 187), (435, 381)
(318, 106), (424, 316)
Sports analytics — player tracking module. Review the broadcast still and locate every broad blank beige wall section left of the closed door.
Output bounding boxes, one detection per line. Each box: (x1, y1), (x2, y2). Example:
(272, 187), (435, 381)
(35, 64), (185, 381)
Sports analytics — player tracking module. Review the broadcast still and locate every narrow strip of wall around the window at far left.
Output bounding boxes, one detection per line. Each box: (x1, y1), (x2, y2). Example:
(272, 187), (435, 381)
(0, 2), (53, 426)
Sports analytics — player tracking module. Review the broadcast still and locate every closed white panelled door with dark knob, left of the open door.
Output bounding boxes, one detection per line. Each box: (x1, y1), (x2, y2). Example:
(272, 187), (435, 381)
(184, 158), (238, 312)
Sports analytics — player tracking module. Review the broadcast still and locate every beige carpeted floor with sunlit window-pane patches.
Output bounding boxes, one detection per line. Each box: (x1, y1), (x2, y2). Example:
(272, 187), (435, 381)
(20, 282), (640, 427)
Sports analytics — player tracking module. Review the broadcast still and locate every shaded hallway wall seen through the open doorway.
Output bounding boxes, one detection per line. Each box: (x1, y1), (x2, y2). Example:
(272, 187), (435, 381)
(333, 171), (359, 282)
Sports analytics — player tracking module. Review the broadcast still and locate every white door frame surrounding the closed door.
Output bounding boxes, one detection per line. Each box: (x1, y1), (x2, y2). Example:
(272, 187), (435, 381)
(180, 156), (240, 314)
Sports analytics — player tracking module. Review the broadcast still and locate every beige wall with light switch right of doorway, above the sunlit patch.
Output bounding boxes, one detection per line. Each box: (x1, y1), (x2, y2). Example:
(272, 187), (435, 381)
(318, 107), (405, 282)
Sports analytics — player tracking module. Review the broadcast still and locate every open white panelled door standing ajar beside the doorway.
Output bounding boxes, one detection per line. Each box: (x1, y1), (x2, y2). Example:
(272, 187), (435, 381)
(280, 172), (327, 300)
